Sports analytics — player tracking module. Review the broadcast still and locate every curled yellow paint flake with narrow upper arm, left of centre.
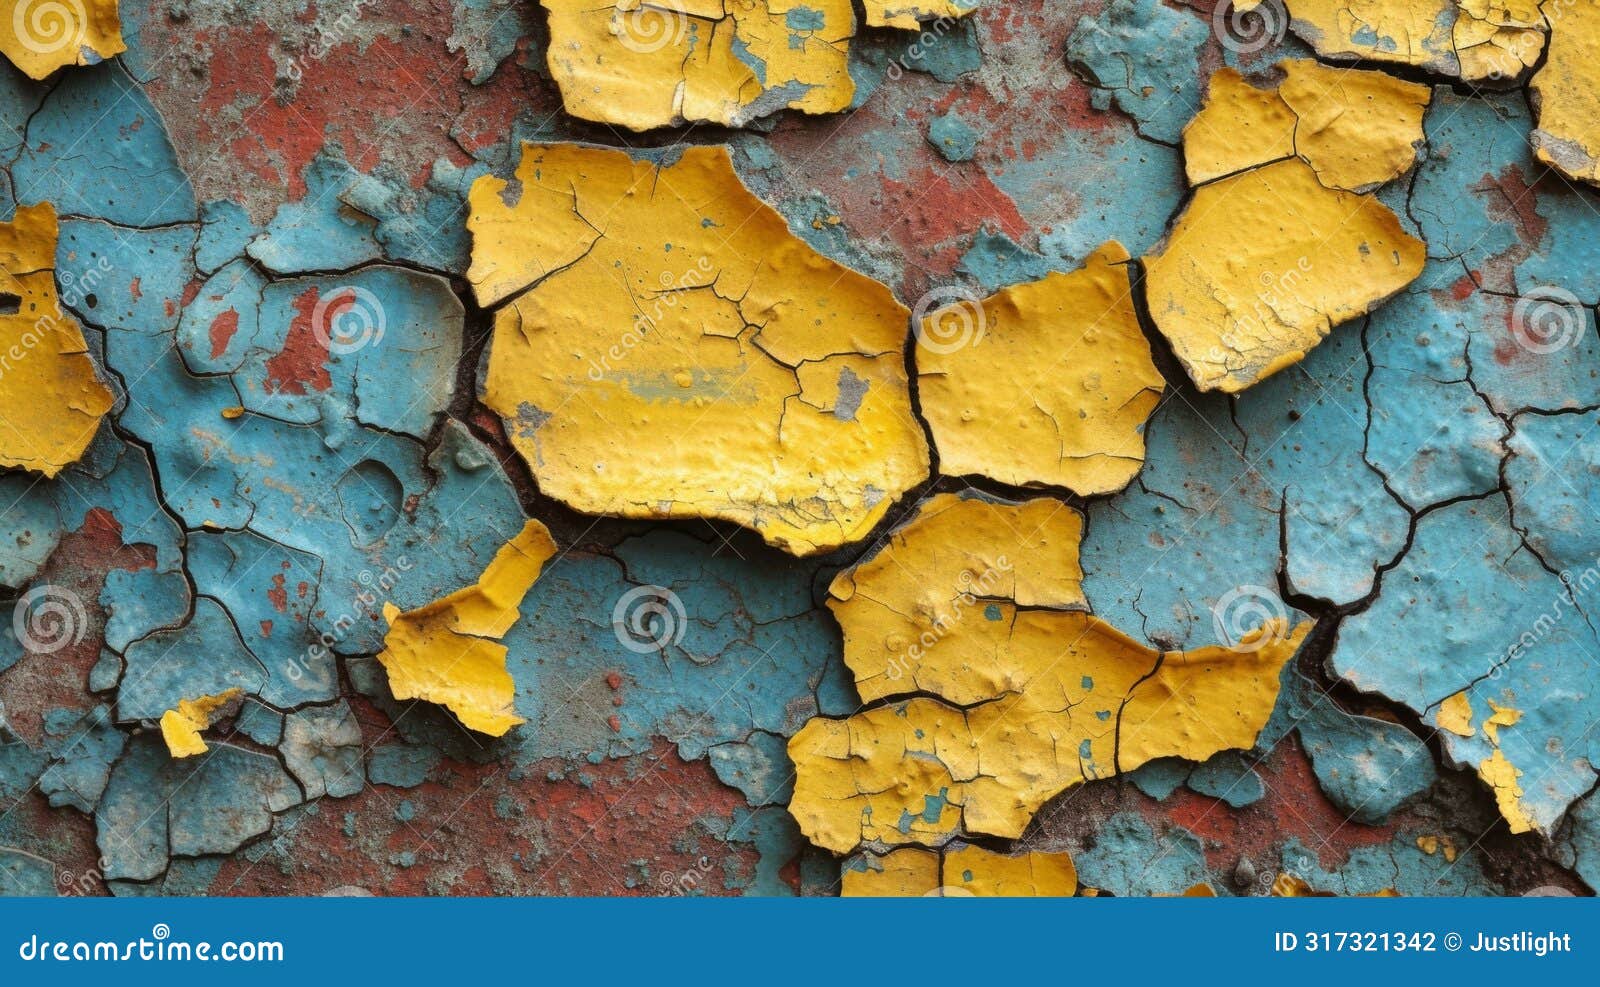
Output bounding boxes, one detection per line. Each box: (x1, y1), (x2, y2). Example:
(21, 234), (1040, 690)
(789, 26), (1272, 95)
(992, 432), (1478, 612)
(378, 520), (555, 737)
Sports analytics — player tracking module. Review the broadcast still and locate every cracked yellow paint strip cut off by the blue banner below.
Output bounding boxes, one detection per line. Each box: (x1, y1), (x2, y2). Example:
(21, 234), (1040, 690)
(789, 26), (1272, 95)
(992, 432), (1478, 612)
(840, 845), (1078, 897)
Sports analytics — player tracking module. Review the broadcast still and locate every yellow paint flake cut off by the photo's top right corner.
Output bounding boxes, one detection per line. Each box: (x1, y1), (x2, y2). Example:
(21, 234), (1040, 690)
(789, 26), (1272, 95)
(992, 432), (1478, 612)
(1530, 0), (1600, 184)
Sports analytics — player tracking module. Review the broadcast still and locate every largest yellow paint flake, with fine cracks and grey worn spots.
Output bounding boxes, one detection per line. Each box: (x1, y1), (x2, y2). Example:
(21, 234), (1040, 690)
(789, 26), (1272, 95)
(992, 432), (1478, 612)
(467, 144), (928, 555)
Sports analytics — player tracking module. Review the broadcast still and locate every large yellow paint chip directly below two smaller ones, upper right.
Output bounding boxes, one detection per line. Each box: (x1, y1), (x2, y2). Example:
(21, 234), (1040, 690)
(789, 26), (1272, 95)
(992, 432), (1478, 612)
(1144, 158), (1426, 392)
